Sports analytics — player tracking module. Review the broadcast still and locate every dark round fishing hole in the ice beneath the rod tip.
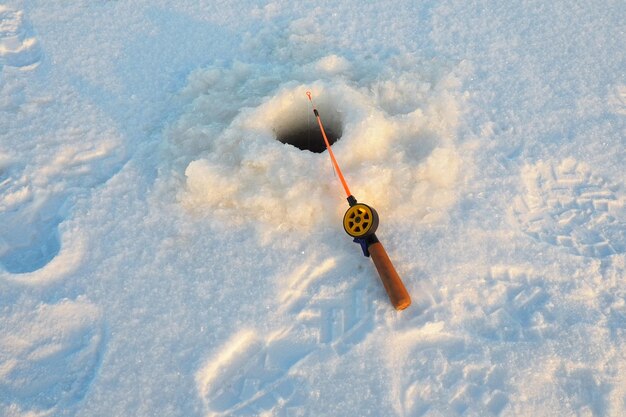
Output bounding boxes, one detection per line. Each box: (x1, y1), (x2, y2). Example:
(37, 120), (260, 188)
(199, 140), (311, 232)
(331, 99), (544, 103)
(274, 97), (343, 153)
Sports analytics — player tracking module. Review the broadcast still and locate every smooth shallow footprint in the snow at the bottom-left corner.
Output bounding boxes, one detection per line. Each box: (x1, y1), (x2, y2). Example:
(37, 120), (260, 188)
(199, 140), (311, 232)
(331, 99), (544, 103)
(0, 298), (104, 415)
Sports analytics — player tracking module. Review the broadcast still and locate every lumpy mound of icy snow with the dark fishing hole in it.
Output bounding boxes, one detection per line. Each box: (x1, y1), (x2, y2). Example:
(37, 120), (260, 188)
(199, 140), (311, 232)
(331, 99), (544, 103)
(165, 57), (463, 236)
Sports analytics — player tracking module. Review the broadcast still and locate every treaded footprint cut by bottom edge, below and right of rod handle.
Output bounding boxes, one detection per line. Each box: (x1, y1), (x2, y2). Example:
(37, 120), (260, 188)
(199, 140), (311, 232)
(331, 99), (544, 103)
(389, 322), (509, 417)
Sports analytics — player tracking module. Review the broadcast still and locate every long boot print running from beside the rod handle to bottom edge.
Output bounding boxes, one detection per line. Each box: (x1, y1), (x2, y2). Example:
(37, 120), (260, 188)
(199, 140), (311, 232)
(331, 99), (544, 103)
(196, 254), (375, 417)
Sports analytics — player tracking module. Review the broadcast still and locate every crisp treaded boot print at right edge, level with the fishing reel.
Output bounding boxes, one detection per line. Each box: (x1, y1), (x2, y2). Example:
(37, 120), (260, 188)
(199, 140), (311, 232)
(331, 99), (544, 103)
(512, 158), (626, 258)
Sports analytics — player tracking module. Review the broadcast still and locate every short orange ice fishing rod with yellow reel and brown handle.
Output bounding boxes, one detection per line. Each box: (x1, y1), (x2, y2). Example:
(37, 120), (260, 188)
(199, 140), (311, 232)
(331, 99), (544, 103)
(306, 91), (411, 310)
